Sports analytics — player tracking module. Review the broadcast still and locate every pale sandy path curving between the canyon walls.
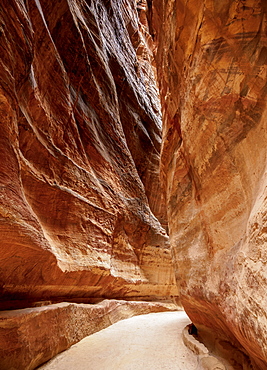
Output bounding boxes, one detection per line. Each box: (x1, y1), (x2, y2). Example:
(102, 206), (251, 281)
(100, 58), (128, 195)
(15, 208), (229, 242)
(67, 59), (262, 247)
(41, 311), (200, 370)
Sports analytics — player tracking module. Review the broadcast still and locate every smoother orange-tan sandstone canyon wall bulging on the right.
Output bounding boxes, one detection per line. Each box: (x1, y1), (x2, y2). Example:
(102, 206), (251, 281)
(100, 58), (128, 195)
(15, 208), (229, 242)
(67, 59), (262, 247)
(154, 0), (267, 369)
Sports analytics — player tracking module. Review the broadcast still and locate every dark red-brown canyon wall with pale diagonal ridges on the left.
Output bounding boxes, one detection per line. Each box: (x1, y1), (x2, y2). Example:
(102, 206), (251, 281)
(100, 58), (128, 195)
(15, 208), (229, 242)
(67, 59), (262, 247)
(0, 0), (176, 307)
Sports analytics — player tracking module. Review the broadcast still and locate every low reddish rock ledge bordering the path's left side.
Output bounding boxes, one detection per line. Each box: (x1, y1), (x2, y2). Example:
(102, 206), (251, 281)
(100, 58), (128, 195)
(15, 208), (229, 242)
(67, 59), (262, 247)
(0, 300), (179, 370)
